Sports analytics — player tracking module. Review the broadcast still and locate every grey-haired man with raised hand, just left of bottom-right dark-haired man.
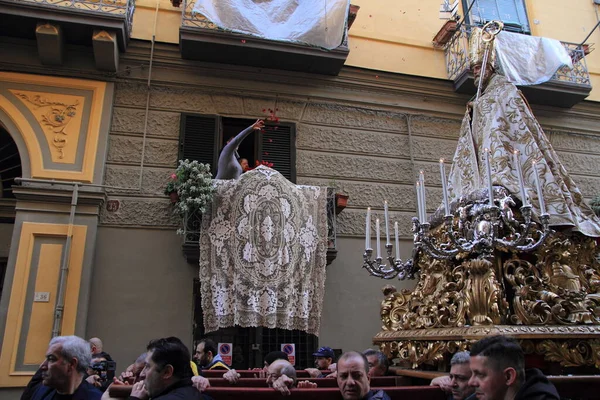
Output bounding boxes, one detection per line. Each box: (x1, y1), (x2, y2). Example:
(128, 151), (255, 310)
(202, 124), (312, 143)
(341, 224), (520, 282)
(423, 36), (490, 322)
(430, 351), (476, 400)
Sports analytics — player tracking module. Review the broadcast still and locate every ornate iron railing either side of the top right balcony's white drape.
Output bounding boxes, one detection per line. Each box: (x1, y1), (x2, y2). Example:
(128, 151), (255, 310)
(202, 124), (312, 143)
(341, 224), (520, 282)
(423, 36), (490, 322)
(444, 26), (590, 85)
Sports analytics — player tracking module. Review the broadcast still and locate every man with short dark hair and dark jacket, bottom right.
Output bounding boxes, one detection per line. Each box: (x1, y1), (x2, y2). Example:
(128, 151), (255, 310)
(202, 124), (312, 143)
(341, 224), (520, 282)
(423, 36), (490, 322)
(469, 336), (560, 400)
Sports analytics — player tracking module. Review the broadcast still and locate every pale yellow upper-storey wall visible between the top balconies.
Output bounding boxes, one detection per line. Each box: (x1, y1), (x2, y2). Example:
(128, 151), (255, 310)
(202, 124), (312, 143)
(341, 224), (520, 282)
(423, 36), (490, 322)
(133, 0), (600, 101)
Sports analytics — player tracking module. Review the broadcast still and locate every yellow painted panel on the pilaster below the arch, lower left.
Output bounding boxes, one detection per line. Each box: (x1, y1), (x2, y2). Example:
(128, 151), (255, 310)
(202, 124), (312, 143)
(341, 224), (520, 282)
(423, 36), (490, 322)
(0, 222), (87, 387)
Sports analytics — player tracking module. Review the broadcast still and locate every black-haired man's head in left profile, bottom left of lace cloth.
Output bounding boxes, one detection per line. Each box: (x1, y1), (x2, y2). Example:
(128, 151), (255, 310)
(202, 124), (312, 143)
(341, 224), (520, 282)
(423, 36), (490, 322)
(143, 336), (193, 397)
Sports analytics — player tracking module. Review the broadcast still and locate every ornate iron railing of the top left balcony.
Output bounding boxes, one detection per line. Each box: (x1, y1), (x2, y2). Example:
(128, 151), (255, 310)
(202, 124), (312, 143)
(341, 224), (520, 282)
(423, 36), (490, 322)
(14, 0), (135, 36)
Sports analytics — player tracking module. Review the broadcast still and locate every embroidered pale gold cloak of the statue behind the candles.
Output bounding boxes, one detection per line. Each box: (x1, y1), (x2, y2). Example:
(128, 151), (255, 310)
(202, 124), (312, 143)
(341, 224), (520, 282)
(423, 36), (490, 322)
(448, 74), (600, 237)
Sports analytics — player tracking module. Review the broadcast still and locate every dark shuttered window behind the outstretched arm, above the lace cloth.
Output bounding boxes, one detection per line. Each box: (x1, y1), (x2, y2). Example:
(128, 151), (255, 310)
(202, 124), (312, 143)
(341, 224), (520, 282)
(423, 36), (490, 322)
(179, 114), (296, 183)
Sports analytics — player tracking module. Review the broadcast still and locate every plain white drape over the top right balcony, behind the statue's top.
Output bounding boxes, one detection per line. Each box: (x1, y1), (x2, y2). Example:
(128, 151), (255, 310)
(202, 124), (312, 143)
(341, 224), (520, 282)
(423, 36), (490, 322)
(496, 31), (573, 85)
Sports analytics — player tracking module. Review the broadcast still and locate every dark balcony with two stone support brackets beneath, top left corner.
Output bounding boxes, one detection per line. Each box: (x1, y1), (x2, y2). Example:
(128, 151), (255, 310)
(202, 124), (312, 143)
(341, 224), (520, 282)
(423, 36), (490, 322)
(0, 0), (135, 71)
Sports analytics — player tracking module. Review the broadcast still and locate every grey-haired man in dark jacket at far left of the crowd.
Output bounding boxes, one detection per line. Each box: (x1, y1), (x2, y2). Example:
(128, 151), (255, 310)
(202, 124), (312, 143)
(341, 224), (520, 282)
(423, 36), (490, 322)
(31, 336), (102, 400)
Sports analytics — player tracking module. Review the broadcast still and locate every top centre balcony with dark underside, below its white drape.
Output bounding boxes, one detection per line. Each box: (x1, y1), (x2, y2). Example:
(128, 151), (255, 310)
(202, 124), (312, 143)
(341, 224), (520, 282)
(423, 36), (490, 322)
(179, 0), (356, 75)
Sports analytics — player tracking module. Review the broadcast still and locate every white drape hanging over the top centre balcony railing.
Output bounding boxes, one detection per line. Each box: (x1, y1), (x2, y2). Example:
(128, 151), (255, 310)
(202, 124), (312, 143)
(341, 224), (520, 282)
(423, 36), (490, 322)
(194, 0), (350, 49)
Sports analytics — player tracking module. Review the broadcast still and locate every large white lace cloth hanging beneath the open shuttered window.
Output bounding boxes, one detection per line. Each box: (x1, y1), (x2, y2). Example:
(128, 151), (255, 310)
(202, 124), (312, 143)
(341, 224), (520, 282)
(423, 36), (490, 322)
(200, 166), (327, 335)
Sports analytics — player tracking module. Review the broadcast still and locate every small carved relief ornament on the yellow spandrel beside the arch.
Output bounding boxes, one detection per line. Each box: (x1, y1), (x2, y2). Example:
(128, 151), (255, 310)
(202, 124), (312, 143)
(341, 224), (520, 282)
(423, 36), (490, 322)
(14, 92), (81, 159)
